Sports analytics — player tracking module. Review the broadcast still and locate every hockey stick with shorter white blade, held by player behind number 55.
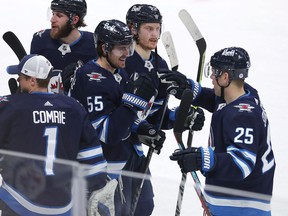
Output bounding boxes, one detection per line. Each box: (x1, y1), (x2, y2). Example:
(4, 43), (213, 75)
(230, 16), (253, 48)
(131, 31), (178, 216)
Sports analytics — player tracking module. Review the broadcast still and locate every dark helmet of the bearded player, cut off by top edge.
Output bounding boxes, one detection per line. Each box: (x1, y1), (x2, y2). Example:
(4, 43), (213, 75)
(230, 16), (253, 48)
(51, 0), (87, 19)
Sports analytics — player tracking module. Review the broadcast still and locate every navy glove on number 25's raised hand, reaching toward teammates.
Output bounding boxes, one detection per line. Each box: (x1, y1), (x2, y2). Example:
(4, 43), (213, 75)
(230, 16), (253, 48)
(158, 70), (201, 100)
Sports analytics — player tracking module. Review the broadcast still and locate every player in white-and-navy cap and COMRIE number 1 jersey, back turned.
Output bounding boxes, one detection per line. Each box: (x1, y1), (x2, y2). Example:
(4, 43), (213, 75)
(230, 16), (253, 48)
(0, 54), (117, 216)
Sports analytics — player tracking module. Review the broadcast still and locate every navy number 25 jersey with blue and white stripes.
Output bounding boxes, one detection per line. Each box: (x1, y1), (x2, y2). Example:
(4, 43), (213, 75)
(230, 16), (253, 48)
(193, 83), (275, 216)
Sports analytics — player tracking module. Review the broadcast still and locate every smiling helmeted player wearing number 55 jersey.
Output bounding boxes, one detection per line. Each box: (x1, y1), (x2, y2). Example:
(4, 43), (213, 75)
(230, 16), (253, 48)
(70, 20), (157, 215)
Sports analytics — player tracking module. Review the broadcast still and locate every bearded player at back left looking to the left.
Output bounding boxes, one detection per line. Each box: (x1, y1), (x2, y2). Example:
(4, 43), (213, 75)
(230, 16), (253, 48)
(30, 0), (97, 93)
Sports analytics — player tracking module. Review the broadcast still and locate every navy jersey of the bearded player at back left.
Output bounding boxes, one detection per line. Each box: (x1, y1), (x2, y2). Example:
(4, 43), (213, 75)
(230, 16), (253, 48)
(30, 29), (97, 93)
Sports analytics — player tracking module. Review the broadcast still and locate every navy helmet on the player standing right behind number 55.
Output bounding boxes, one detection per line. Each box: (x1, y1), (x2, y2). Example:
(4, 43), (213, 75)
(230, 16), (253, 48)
(126, 4), (162, 28)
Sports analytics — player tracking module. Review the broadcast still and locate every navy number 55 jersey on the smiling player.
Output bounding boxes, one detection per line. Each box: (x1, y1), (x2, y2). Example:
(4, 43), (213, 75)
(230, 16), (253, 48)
(70, 60), (136, 178)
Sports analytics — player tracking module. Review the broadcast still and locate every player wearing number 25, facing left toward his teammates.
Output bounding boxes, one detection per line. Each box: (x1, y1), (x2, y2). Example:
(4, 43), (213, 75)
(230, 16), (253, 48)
(170, 47), (275, 216)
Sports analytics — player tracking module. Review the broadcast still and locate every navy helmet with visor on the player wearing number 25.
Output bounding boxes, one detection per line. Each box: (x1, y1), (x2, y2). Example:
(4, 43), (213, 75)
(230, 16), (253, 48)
(209, 47), (250, 80)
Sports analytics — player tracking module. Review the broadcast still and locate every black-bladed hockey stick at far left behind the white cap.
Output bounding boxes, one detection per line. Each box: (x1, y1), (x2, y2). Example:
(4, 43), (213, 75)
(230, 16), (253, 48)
(3, 31), (27, 94)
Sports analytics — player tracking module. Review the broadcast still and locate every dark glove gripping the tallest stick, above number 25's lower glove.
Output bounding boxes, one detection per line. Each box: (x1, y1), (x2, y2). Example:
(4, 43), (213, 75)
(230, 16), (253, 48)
(184, 107), (205, 131)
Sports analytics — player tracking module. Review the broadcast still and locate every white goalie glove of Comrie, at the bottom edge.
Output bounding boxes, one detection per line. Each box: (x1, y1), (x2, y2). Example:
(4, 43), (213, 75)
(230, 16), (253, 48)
(87, 179), (118, 216)
